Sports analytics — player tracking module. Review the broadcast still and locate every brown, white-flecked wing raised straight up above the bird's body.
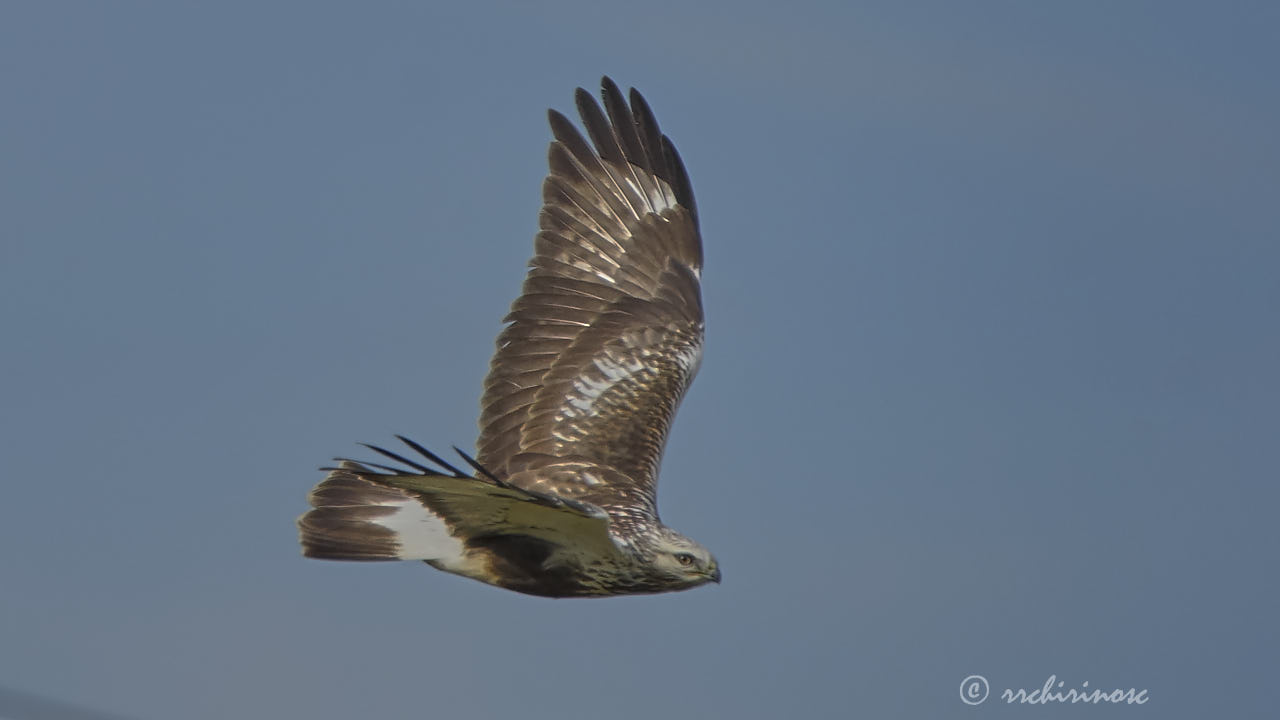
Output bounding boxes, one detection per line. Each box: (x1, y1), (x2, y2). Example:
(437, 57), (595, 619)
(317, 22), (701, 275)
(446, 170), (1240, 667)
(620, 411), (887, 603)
(477, 78), (703, 510)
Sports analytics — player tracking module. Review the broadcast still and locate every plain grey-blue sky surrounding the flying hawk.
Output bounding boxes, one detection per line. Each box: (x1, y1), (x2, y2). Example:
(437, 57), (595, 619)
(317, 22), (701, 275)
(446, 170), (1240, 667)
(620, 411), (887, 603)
(0, 0), (1280, 720)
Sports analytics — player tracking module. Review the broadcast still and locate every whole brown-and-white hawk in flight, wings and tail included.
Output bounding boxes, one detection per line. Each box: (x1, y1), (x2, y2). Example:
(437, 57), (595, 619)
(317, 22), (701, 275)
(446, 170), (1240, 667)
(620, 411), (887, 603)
(298, 77), (721, 597)
